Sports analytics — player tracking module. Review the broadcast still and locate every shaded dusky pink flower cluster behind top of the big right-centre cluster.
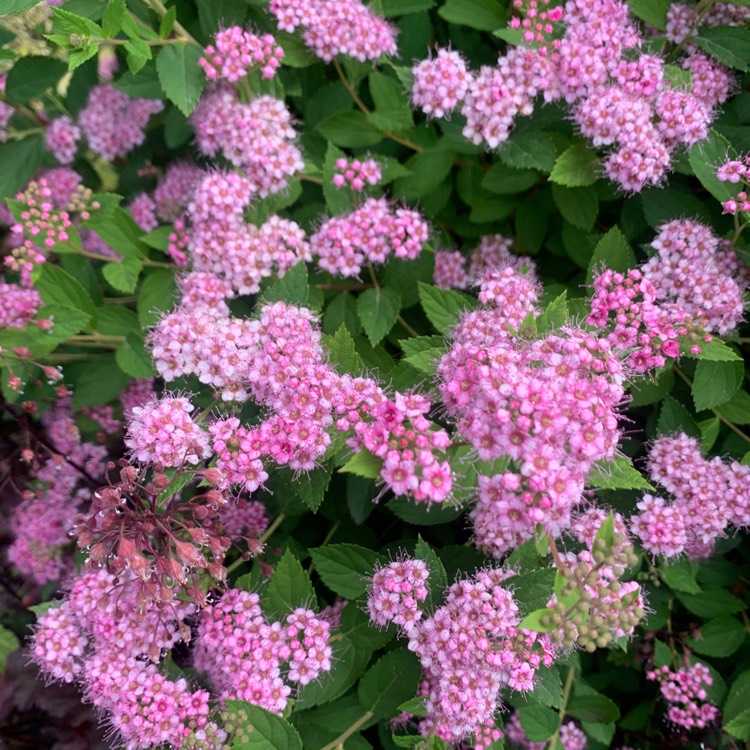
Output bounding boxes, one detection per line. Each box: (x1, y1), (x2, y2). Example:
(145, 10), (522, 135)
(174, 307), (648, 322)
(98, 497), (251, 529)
(432, 234), (536, 289)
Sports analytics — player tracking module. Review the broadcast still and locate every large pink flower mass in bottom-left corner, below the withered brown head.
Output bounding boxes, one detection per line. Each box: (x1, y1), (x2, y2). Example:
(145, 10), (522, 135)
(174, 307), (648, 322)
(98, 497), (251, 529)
(31, 570), (226, 750)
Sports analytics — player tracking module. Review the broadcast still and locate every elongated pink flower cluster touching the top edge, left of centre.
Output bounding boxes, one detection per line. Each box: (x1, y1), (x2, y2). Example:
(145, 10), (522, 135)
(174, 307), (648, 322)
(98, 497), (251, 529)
(269, 0), (398, 62)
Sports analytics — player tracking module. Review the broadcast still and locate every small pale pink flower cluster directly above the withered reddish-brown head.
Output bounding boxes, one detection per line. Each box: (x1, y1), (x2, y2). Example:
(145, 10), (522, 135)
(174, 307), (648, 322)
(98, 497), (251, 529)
(125, 396), (211, 467)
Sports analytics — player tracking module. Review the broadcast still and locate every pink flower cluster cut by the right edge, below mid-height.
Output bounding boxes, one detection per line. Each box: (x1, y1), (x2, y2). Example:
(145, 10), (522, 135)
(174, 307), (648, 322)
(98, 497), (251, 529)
(630, 433), (750, 558)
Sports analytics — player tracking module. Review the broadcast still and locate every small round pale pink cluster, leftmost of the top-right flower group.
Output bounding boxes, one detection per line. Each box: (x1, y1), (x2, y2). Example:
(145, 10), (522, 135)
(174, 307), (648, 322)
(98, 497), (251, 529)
(411, 47), (471, 117)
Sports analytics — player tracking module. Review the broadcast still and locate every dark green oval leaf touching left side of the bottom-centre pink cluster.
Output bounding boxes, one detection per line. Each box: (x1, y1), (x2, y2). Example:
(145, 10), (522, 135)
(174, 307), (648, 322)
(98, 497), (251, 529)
(357, 648), (422, 718)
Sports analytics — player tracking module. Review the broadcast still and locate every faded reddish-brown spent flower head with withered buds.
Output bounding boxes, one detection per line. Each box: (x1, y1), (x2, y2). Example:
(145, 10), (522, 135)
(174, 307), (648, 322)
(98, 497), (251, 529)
(75, 459), (231, 606)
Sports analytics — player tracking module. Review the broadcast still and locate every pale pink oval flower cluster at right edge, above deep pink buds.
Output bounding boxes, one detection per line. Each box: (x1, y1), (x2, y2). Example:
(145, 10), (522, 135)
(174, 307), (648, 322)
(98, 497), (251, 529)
(642, 219), (750, 334)
